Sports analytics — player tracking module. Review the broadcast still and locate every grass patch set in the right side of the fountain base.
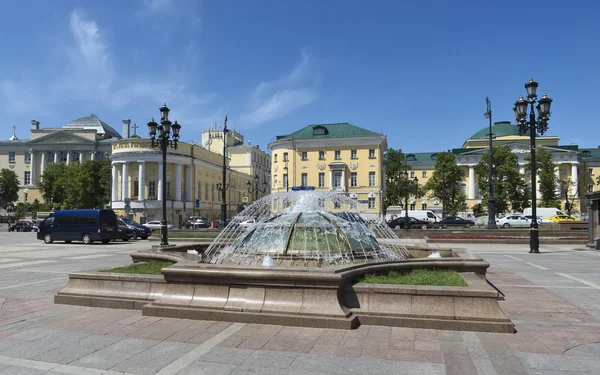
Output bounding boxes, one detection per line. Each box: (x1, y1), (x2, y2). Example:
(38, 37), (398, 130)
(360, 268), (467, 286)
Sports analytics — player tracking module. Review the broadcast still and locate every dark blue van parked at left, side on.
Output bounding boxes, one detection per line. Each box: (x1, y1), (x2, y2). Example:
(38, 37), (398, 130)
(37, 210), (119, 244)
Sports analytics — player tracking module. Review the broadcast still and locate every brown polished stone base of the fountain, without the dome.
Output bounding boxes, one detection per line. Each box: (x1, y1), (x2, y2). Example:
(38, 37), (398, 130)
(55, 249), (514, 333)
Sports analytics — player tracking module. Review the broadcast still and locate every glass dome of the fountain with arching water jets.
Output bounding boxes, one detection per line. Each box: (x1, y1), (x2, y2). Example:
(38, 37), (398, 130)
(203, 191), (408, 267)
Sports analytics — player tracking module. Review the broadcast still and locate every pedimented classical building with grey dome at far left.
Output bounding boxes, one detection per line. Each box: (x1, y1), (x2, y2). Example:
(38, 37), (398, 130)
(0, 115), (121, 206)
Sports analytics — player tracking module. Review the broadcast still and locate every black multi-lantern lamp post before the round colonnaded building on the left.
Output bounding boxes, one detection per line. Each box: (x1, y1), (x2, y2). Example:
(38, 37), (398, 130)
(148, 104), (181, 246)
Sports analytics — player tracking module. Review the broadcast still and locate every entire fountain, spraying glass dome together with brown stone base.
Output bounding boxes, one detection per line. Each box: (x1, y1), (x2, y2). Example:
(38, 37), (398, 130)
(55, 191), (514, 332)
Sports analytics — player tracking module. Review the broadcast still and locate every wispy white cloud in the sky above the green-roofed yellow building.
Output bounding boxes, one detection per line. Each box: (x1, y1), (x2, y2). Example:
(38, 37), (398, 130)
(241, 53), (317, 128)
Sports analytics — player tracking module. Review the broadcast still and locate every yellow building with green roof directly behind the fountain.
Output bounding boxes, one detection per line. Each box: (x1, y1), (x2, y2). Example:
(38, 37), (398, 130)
(268, 123), (387, 214)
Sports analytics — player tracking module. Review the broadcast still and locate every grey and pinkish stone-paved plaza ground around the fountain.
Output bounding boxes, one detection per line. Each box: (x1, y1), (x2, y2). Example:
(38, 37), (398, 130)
(0, 233), (600, 375)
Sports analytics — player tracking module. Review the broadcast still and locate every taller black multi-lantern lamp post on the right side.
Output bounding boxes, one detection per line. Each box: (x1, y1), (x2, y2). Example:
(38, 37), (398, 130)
(514, 78), (552, 254)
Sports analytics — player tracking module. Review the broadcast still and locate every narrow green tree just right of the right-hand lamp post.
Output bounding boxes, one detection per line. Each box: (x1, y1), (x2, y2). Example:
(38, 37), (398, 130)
(525, 148), (560, 208)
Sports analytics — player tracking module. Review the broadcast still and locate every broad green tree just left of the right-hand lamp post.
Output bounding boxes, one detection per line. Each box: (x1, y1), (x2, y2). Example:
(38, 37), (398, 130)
(475, 146), (530, 213)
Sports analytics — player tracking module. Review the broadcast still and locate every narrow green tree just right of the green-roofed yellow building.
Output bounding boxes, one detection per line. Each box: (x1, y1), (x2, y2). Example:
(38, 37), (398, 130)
(383, 148), (410, 208)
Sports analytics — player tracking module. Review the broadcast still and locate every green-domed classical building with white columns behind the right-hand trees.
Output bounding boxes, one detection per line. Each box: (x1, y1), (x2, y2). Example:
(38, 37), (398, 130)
(406, 122), (600, 213)
